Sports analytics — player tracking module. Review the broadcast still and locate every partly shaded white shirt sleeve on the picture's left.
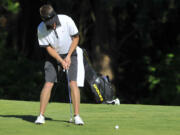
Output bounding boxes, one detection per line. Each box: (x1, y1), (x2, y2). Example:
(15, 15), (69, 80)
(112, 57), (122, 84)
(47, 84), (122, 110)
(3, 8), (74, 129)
(37, 28), (49, 47)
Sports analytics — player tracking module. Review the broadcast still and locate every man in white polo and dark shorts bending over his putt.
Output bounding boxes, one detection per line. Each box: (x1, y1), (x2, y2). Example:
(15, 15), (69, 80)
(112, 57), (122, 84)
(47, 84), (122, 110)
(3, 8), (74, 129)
(35, 4), (84, 125)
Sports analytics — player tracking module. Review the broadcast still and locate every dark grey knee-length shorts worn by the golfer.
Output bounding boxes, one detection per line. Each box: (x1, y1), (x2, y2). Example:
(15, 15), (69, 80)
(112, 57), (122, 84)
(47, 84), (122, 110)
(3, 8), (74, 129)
(44, 51), (78, 82)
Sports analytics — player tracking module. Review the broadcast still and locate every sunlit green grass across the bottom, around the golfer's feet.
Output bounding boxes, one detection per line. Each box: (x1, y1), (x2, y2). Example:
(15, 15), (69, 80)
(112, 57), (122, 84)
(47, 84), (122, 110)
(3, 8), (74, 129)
(0, 100), (180, 135)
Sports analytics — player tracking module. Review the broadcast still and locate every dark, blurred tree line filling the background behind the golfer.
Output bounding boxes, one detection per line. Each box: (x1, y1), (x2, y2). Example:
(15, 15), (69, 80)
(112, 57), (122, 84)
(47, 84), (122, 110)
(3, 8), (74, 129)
(0, 0), (180, 105)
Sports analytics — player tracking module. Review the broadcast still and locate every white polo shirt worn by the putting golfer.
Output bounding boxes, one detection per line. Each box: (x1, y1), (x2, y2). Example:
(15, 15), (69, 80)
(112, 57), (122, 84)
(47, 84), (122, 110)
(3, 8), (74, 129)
(38, 15), (78, 54)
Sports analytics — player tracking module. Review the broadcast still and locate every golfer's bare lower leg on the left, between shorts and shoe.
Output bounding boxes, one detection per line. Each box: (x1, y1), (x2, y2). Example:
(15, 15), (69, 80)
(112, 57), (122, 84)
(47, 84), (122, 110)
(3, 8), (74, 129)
(40, 82), (54, 115)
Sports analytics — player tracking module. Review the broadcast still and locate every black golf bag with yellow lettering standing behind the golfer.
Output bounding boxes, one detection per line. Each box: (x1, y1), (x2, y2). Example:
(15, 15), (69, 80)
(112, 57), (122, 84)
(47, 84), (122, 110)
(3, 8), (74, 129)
(83, 49), (120, 104)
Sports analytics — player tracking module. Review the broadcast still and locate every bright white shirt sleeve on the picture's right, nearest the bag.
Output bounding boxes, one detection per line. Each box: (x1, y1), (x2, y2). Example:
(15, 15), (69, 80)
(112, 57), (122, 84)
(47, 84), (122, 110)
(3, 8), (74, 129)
(68, 17), (79, 36)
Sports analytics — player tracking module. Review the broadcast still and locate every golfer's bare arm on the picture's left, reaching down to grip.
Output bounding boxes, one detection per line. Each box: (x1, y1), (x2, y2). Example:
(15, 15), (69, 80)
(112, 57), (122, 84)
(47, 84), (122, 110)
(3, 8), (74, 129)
(46, 46), (68, 69)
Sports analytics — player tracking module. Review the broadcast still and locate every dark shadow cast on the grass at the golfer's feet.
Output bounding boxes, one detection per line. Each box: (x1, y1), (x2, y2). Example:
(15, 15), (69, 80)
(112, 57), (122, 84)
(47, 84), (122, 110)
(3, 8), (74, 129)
(0, 115), (69, 123)
